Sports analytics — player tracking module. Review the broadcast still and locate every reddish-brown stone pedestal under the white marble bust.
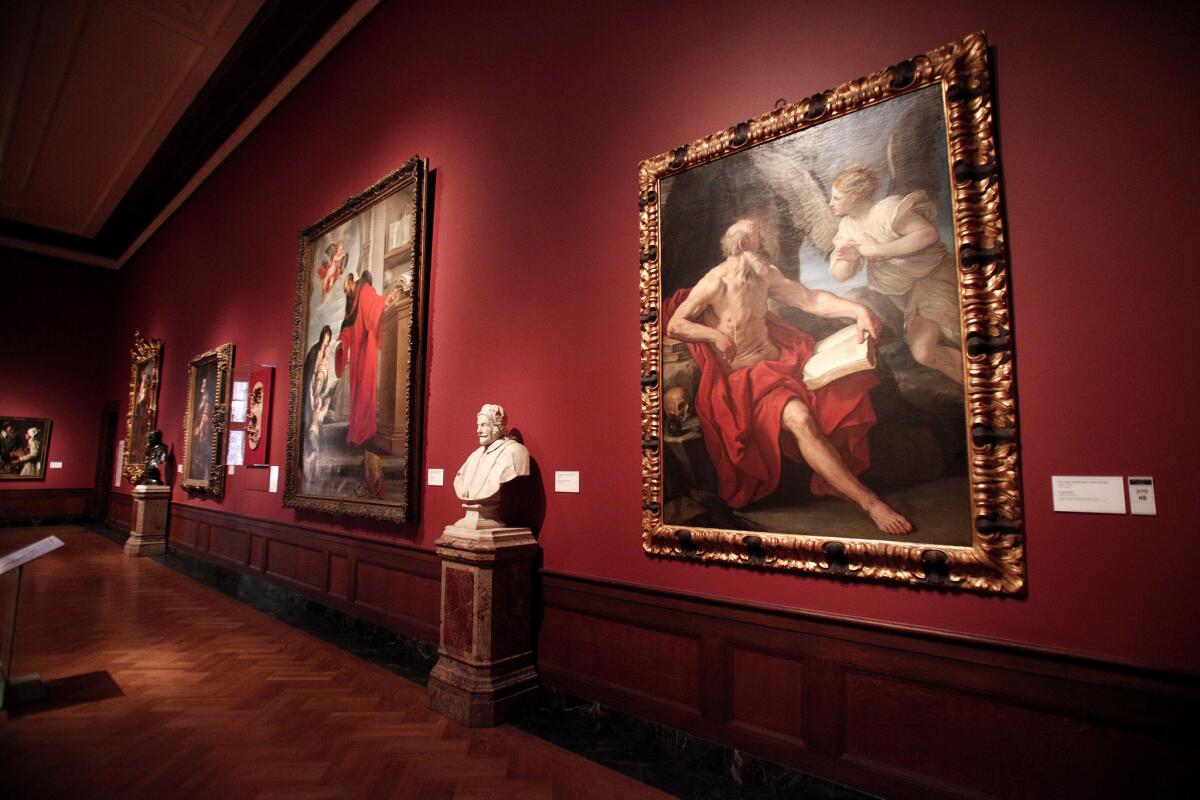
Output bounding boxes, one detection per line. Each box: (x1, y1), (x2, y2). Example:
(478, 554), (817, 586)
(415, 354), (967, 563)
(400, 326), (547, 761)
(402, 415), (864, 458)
(428, 524), (538, 728)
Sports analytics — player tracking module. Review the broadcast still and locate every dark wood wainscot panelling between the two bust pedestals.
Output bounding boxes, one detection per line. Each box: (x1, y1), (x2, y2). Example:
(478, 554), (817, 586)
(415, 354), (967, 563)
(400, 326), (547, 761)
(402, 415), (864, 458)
(167, 503), (442, 643)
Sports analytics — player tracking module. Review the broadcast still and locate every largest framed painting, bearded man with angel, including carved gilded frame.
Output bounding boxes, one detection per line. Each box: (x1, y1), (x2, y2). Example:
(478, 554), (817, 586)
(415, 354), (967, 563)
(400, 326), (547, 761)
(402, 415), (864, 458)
(640, 34), (1025, 593)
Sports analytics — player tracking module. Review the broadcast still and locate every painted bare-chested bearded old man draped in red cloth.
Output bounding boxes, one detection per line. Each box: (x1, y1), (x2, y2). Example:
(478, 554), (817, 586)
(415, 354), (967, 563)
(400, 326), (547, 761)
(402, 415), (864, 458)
(666, 219), (912, 535)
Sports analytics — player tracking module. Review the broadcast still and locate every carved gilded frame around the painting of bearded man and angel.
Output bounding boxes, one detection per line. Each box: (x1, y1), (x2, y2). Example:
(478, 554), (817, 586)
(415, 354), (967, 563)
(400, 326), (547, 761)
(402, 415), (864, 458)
(640, 34), (1025, 594)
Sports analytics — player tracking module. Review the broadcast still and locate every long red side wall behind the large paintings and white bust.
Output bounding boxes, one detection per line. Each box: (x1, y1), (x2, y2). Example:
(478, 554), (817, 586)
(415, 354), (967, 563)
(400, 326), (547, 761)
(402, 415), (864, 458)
(108, 2), (1200, 669)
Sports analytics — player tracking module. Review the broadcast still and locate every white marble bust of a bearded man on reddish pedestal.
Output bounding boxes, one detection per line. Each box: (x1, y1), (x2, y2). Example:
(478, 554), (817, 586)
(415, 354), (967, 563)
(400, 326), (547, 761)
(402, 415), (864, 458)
(454, 403), (529, 529)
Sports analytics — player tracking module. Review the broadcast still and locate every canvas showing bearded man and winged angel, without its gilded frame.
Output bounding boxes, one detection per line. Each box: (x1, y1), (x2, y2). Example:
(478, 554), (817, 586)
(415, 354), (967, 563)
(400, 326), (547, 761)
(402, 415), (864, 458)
(662, 88), (968, 543)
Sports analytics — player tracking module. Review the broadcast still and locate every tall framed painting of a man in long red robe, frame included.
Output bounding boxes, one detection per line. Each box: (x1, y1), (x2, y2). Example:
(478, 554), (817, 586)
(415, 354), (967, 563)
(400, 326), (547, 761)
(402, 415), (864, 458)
(283, 156), (428, 522)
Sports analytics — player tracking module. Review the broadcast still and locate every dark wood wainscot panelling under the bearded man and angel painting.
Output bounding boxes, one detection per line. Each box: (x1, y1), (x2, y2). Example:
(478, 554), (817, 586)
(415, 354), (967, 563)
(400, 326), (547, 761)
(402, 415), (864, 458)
(538, 572), (1200, 800)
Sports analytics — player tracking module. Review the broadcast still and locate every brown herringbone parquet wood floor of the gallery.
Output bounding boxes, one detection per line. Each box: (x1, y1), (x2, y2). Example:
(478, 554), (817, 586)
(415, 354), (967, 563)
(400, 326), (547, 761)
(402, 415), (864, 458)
(0, 525), (668, 800)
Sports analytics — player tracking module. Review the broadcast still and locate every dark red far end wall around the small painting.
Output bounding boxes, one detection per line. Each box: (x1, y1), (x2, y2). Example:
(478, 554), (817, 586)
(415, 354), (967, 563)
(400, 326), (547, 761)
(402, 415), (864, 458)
(0, 249), (117, 491)
